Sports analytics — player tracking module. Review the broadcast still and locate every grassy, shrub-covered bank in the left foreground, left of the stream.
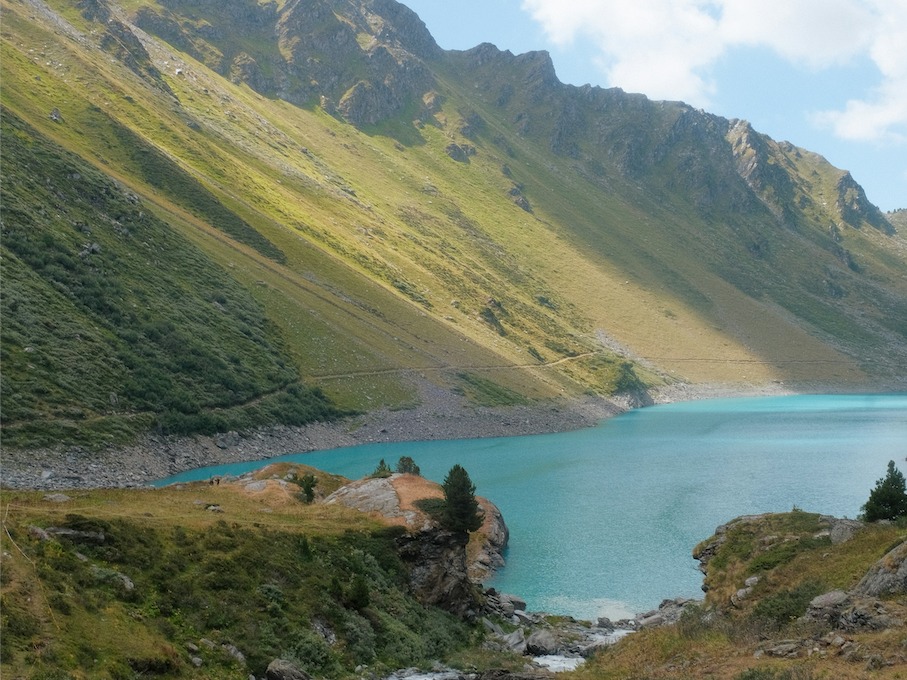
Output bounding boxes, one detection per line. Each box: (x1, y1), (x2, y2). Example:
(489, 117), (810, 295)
(0, 478), (478, 678)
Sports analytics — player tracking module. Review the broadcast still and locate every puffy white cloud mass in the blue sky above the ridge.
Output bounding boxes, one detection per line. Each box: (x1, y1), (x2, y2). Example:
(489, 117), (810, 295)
(522, 0), (907, 140)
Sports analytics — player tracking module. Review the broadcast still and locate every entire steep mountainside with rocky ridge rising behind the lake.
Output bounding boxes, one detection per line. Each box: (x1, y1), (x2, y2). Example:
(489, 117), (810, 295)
(0, 0), (907, 446)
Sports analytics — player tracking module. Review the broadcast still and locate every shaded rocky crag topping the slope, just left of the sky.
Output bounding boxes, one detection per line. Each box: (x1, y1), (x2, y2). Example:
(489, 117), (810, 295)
(133, 0), (440, 126)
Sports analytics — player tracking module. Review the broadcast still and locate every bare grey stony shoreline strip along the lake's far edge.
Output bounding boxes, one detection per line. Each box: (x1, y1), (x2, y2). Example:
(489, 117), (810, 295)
(0, 381), (892, 491)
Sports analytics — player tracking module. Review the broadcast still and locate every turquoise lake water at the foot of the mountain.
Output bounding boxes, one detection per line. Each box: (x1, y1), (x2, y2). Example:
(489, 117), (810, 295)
(160, 395), (907, 620)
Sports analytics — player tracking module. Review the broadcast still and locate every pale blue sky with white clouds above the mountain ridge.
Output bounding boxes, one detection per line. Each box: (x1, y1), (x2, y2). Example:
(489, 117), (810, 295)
(401, 0), (907, 211)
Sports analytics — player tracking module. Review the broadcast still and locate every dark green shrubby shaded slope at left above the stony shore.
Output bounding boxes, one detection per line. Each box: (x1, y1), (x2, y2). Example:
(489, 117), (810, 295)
(2, 110), (339, 446)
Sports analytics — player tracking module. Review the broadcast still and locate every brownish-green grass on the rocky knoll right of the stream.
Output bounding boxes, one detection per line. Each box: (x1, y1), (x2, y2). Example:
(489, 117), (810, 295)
(569, 510), (904, 680)
